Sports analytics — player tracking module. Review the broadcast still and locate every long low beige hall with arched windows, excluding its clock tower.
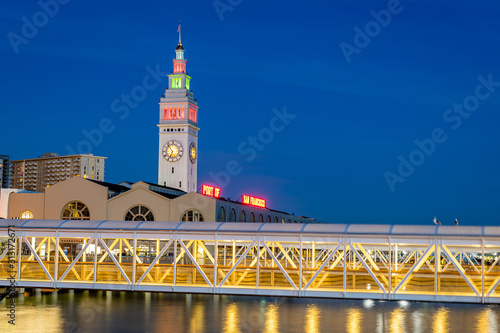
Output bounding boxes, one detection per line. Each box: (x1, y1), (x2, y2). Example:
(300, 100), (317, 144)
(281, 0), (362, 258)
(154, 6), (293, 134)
(0, 177), (317, 223)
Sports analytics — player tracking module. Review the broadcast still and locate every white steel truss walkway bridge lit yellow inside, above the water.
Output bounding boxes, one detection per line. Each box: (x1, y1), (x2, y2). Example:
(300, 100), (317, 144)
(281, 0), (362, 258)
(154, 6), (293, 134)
(0, 220), (500, 303)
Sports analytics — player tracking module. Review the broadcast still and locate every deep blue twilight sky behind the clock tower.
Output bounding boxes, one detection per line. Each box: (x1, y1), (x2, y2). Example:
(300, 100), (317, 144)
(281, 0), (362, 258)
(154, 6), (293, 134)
(0, 0), (500, 225)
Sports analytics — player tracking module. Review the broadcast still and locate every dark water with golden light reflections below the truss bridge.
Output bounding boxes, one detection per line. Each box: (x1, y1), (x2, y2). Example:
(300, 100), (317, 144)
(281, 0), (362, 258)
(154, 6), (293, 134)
(0, 291), (500, 333)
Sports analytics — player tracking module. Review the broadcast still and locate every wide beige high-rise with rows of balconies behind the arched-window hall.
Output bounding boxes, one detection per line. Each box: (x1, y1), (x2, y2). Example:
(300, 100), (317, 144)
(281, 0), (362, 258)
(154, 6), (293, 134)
(10, 153), (106, 192)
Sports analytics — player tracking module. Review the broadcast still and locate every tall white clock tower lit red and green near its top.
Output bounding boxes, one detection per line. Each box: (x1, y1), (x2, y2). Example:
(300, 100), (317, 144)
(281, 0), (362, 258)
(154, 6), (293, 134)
(158, 24), (200, 192)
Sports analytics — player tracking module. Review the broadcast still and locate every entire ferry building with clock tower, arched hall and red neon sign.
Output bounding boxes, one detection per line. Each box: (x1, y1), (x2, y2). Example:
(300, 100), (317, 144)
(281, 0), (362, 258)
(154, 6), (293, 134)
(0, 35), (317, 223)
